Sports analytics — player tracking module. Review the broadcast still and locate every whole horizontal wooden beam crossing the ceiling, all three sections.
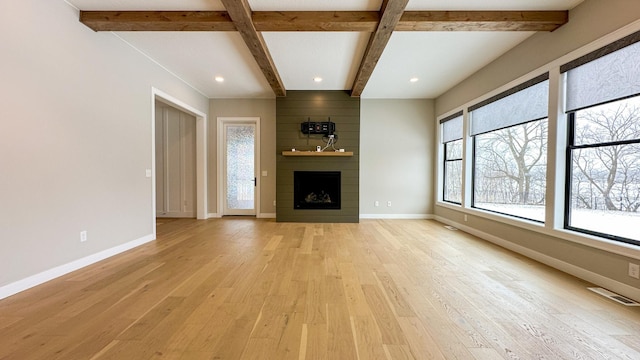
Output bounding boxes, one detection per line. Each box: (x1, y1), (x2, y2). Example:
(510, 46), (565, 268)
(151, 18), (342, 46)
(80, 11), (568, 32)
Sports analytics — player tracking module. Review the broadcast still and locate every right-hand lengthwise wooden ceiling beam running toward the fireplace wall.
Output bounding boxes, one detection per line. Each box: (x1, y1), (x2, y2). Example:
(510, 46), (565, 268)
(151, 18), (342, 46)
(351, 0), (409, 97)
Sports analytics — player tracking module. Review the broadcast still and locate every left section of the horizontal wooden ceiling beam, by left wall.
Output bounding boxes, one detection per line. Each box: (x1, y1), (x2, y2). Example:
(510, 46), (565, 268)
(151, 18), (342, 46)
(80, 11), (236, 31)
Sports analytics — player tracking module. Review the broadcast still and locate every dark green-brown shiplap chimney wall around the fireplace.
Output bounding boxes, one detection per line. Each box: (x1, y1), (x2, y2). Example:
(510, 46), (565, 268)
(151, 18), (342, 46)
(276, 91), (360, 223)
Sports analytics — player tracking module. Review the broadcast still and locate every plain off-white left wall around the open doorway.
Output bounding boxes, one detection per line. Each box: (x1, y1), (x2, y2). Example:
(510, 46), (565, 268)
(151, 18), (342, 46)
(0, 0), (208, 297)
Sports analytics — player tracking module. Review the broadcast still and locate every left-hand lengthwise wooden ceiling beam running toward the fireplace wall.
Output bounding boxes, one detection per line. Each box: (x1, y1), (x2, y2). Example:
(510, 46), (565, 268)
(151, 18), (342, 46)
(221, 0), (287, 96)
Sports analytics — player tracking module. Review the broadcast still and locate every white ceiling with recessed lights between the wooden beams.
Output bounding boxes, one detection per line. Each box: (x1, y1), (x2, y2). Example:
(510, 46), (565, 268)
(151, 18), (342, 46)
(65, 0), (583, 99)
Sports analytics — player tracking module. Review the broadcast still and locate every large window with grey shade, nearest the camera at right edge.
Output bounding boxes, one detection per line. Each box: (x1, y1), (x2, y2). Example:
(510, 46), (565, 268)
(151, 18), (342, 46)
(561, 33), (640, 244)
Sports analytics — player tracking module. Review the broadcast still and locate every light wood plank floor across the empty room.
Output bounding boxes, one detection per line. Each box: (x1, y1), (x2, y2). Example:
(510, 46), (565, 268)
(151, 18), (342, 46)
(0, 218), (640, 360)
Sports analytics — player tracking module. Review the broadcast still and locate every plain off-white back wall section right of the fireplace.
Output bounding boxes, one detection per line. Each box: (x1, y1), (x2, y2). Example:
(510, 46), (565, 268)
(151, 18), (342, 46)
(360, 99), (435, 218)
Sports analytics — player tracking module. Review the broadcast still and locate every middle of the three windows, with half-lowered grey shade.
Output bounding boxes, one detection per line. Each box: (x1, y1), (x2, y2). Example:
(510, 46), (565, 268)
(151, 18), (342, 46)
(469, 73), (549, 222)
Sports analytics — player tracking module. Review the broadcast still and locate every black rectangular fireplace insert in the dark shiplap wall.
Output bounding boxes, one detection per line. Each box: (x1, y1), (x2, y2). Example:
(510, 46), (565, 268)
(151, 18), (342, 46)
(293, 171), (341, 210)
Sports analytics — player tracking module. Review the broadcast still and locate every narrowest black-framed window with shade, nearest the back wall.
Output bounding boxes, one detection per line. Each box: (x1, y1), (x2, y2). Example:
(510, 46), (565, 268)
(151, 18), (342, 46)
(440, 111), (463, 204)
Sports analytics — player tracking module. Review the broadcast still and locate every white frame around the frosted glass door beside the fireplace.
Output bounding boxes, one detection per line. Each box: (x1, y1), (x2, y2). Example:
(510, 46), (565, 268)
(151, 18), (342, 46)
(217, 116), (261, 218)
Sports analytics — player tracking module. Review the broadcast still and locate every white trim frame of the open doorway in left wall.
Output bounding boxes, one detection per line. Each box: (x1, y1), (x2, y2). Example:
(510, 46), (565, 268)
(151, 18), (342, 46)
(151, 87), (208, 239)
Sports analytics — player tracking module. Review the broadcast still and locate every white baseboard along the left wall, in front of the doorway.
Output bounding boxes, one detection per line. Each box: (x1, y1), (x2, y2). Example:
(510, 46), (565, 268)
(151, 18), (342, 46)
(0, 234), (155, 299)
